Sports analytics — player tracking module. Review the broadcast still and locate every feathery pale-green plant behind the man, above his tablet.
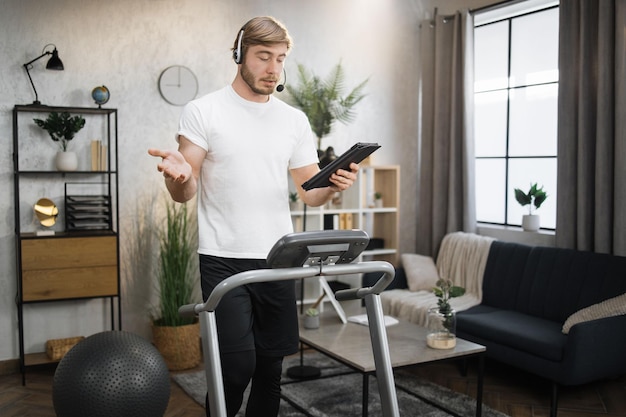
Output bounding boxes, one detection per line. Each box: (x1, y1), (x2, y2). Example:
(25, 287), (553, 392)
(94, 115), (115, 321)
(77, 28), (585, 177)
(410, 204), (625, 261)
(285, 62), (368, 158)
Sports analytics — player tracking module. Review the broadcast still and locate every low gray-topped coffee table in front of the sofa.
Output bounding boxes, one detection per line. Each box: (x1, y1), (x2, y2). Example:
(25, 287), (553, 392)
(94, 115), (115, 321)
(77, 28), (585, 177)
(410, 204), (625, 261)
(300, 310), (486, 417)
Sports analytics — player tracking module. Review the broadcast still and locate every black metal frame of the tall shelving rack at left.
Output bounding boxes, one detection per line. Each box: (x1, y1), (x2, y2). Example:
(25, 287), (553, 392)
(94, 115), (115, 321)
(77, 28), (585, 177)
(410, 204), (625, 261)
(13, 104), (122, 385)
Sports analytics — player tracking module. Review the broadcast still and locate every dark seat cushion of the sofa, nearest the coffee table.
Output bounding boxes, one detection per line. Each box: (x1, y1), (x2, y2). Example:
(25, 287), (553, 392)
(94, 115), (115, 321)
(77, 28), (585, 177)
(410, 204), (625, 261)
(457, 305), (567, 362)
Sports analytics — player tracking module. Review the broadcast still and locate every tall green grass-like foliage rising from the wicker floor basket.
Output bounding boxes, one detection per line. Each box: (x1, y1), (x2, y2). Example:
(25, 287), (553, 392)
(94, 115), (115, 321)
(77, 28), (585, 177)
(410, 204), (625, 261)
(154, 202), (197, 326)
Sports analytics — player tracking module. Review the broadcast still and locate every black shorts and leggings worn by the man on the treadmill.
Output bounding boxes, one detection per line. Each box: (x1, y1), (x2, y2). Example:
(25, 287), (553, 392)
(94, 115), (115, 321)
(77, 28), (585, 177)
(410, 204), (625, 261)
(200, 255), (298, 417)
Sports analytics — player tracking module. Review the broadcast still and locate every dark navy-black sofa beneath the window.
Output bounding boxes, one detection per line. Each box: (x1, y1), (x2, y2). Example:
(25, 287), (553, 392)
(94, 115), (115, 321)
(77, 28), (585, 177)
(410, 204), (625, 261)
(363, 241), (626, 417)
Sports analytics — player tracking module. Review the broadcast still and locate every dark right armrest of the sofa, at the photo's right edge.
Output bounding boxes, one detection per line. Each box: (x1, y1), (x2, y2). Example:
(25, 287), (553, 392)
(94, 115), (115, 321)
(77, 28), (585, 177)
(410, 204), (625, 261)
(560, 315), (626, 385)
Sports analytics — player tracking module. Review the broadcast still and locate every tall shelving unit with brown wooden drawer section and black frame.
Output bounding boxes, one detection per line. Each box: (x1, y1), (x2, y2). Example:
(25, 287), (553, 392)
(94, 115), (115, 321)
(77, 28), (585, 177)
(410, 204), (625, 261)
(13, 105), (122, 383)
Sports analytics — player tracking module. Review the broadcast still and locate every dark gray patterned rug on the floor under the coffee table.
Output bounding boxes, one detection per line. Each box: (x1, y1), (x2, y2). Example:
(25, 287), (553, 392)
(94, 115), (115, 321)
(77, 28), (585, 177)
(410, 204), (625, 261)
(173, 353), (506, 417)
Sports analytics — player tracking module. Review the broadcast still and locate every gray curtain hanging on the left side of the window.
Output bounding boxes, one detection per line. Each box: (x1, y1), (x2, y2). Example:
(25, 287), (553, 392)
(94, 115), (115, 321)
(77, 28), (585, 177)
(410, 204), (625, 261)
(416, 12), (476, 256)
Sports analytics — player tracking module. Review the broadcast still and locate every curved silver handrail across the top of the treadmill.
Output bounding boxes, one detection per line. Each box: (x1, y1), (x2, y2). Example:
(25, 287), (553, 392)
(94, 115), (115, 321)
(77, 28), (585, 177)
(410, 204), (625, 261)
(178, 261), (395, 317)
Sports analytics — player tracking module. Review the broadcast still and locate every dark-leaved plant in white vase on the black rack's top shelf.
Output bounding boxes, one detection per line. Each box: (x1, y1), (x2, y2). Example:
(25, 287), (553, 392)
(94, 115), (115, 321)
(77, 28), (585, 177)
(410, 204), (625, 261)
(33, 112), (85, 171)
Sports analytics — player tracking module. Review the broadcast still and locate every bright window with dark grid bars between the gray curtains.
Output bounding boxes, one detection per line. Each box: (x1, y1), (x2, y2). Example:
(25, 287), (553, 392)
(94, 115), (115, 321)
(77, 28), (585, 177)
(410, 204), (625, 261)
(474, 1), (559, 229)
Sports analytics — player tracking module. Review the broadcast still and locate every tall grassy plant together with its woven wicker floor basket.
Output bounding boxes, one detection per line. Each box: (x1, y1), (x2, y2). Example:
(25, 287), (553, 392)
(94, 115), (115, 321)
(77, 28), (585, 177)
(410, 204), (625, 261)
(152, 202), (201, 370)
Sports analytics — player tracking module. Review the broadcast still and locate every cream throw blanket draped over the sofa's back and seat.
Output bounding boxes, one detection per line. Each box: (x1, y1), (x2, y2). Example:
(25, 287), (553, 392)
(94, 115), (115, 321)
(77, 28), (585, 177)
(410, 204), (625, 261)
(380, 232), (494, 326)
